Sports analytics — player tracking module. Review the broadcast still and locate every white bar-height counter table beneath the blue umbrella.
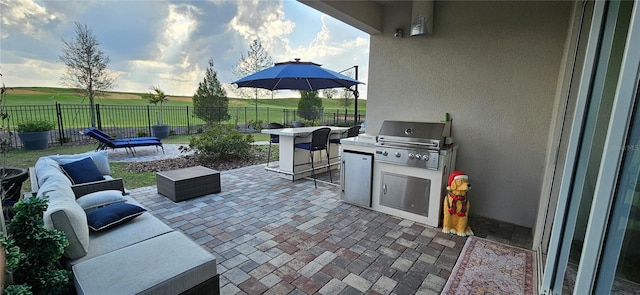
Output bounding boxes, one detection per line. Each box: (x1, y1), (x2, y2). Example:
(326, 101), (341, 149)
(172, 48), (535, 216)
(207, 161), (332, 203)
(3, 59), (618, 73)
(262, 126), (348, 180)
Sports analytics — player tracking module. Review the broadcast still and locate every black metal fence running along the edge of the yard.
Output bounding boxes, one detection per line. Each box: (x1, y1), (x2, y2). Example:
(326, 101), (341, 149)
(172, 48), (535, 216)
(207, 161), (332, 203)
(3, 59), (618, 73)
(2, 103), (365, 148)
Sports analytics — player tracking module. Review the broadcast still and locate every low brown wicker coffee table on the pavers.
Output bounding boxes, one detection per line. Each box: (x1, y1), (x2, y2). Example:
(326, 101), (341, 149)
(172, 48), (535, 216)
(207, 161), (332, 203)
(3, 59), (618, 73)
(156, 166), (221, 202)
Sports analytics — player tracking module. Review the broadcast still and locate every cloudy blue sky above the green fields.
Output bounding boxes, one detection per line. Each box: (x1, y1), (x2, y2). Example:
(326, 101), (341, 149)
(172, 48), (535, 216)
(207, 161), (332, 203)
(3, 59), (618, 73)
(0, 0), (369, 99)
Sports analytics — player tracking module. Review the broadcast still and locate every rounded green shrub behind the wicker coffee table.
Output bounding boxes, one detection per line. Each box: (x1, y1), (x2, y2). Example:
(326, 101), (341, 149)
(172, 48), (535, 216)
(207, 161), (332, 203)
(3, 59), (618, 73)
(189, 124), (253, 162)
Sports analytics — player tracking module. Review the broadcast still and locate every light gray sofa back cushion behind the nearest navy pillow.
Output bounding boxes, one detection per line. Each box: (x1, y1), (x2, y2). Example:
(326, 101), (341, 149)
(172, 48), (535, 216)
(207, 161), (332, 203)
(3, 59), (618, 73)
(37, 182), (89, 259)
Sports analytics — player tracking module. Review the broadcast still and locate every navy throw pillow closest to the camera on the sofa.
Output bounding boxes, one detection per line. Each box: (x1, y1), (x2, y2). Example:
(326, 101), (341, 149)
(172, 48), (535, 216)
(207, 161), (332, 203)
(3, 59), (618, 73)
(87, 203), (147, 231)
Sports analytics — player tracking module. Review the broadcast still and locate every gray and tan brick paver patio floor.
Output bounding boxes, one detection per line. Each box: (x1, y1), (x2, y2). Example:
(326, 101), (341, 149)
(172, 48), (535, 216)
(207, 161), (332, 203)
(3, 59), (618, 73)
(130, 165), (531, 294)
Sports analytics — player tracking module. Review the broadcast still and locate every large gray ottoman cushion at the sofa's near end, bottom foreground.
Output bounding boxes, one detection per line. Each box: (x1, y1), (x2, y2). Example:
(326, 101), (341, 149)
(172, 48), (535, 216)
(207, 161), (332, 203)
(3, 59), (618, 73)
(73, 231), (217, 295)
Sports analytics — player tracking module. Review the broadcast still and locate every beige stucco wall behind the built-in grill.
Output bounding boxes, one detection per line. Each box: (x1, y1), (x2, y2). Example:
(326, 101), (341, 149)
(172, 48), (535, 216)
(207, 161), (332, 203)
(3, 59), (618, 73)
(367, 1), (572, 227)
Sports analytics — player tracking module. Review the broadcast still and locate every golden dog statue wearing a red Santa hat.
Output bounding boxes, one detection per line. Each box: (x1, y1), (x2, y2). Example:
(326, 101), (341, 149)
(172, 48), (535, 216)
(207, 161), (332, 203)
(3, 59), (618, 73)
(442, 171), (473, 236)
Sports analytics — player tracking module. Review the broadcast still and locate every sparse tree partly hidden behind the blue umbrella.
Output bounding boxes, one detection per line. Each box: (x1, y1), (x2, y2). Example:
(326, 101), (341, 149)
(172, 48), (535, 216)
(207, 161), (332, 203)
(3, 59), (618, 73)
(233, 39), (273, 121)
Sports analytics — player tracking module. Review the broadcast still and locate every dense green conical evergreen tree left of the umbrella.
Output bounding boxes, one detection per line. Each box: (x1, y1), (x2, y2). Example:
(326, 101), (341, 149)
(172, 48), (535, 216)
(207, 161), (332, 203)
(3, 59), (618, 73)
(193, 59), (231, 124)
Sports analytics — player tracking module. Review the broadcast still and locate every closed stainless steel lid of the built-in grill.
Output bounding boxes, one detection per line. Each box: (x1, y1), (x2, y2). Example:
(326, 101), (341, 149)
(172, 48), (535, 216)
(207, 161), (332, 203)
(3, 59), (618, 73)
(378, 121), (451, 149)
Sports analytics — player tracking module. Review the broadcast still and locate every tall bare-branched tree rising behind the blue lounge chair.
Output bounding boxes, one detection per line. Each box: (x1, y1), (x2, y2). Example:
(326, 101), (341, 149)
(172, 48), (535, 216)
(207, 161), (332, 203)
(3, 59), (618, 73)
(59, 22), (115, 127)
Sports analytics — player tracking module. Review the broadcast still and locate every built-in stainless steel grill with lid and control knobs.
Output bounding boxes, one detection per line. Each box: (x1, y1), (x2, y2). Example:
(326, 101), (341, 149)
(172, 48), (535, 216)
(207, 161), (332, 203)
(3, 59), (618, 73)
(375, 121), (451, 170)
